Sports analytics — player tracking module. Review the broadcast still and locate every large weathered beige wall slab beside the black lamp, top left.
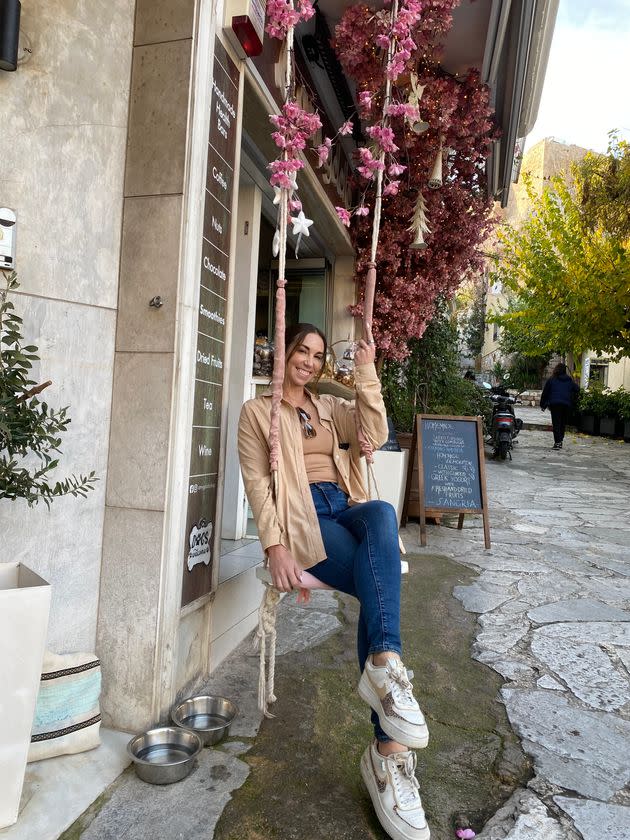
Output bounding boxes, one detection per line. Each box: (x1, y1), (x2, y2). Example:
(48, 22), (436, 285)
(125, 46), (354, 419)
(0, 0), (133, 307)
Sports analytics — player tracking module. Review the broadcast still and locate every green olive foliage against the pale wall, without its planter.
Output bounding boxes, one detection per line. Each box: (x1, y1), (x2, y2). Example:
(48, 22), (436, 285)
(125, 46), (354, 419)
(0, 272), (97, 506)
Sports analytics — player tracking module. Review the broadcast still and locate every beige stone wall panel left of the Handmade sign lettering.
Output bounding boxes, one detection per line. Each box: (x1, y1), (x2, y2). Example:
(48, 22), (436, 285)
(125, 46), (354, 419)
(125, 39), (192, 196)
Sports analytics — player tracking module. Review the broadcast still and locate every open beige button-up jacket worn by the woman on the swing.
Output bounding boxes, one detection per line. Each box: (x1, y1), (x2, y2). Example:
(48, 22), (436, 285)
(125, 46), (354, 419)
(238, 364), (388, 569)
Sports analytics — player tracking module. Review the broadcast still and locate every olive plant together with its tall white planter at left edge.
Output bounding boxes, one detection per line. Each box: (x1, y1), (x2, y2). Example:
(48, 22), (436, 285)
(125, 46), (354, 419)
(0, 272), (96, 829)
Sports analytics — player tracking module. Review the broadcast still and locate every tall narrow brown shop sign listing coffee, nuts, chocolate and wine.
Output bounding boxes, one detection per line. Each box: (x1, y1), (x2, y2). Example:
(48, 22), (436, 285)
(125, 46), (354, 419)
(182, 39), (239, 606)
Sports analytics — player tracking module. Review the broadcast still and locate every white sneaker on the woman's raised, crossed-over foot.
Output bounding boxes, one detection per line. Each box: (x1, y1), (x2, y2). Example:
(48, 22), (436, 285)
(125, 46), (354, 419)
(359, 656), (429, 749)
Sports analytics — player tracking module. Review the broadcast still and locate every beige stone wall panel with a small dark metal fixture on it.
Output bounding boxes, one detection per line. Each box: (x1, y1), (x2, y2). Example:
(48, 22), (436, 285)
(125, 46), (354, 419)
(116, 195), (182, 353)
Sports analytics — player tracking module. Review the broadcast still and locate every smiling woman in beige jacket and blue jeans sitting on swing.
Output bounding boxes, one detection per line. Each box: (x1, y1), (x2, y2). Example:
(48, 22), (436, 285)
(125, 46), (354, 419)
(238, 324), (429, 840)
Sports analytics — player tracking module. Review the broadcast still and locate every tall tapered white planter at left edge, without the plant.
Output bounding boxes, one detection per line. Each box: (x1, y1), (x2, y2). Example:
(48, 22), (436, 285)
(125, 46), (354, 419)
(0, 563), (50, 828)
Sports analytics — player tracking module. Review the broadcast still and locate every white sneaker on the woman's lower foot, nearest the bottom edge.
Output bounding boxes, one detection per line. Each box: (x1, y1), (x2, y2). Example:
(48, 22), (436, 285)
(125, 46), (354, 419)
(361, 741), (431, 840)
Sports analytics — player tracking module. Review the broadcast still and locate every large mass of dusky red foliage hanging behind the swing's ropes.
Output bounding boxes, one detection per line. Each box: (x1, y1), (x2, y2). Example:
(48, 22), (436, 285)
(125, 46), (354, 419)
(334, 0), (496, 360)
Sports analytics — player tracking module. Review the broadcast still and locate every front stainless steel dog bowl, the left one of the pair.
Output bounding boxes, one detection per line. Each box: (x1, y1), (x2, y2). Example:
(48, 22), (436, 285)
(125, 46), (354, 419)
(127, 726), (201, 785)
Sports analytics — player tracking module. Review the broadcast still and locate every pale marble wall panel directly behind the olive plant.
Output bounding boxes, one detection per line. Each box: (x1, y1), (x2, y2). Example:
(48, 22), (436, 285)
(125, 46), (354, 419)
(0, 295), (116, 653)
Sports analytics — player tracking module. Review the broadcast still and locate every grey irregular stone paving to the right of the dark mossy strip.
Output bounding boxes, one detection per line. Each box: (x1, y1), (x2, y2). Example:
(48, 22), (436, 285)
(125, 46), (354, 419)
(403, 426), (630, 840)
